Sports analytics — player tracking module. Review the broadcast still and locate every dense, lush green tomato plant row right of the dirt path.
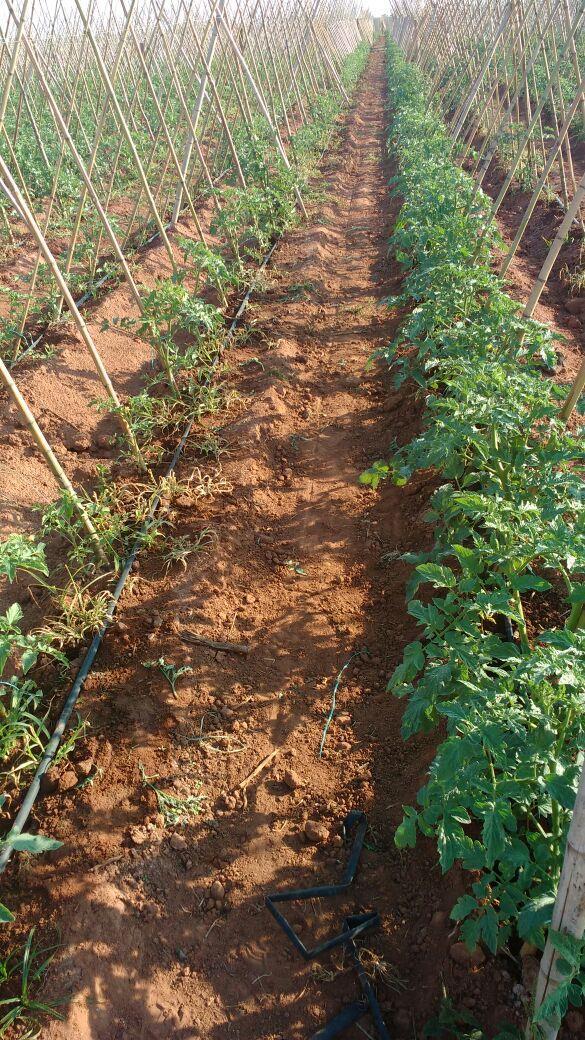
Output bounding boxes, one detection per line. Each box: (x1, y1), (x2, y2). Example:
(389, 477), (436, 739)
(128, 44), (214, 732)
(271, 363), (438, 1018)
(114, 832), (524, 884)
(362, 42), (585, 1017)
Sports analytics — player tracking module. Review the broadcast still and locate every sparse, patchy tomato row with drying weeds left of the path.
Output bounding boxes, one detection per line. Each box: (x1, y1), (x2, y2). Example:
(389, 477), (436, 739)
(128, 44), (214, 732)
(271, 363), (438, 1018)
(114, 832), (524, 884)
(0, 48), (370, 919)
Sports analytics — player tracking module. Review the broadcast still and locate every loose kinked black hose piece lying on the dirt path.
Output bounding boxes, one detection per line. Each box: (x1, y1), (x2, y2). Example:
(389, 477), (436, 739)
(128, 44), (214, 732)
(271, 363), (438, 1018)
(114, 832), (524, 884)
(265, 809), (390, 1040)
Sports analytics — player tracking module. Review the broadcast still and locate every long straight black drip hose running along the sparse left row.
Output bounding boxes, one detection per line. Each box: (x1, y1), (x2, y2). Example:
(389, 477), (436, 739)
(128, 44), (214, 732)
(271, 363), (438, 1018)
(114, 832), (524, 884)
(0, 237), (280, 874)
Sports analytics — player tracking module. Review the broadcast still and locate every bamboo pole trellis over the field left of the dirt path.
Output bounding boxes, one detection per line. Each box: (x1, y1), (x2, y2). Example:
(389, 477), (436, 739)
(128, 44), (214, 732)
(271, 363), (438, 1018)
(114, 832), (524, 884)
(0, 0), (373, 530)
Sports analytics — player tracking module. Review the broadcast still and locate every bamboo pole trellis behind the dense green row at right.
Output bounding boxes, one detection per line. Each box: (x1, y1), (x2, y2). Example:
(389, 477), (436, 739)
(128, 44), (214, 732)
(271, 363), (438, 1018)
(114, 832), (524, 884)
(390, 0), (585, 316)
